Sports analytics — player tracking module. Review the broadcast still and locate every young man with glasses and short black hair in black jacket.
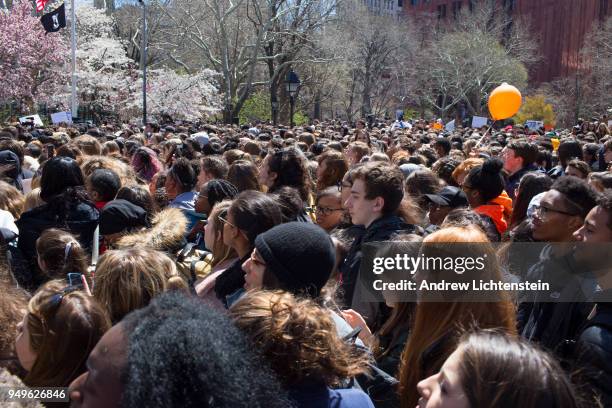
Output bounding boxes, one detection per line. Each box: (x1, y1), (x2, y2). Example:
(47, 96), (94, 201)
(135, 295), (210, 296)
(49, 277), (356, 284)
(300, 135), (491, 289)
(517, 176), (598, 350)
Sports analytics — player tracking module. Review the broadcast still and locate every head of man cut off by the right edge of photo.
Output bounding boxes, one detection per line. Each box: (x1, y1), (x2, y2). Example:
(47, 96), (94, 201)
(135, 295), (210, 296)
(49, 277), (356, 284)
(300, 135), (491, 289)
(574, 190), (612, 242)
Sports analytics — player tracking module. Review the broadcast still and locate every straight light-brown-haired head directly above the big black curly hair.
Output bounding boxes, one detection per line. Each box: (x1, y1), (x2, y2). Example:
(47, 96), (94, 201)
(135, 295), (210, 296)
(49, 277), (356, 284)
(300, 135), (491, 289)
(93, 248), (186, 323)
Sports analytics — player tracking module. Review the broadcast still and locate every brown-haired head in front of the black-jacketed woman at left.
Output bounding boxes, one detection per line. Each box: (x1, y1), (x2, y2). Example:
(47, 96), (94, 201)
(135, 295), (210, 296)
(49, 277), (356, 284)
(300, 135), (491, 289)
(36, 228), (88, 279)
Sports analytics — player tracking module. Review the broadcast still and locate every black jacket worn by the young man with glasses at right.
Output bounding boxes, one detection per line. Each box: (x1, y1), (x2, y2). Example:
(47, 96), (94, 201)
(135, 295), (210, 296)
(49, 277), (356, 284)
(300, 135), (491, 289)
(517, 245), (597, 351)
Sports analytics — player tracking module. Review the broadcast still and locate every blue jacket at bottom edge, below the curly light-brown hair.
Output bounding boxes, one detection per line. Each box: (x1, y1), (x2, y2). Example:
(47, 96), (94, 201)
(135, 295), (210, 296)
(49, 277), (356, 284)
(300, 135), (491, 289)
(288, 383), (374, 408)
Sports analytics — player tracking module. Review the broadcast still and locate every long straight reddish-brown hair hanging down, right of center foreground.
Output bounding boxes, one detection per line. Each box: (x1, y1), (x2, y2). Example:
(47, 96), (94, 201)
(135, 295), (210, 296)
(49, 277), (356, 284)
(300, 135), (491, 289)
(399, 227), (516, 408)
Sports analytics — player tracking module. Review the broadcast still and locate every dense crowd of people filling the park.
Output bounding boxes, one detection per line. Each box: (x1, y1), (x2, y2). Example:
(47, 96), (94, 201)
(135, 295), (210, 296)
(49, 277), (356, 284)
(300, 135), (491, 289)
(0, 117), (612, 408)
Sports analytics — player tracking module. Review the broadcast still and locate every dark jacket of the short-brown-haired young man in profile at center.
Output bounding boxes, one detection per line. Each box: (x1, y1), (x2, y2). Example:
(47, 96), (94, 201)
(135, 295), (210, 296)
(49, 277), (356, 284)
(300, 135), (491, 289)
(339, 215), (423, 307)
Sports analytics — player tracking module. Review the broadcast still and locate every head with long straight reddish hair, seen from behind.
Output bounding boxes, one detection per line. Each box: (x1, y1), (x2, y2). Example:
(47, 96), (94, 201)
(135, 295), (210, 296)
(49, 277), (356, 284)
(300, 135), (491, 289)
(399, 226), (516, 407)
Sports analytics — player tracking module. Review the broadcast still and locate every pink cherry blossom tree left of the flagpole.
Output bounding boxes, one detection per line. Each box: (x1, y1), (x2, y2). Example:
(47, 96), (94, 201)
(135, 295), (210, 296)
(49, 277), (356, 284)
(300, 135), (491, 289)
(0, 0), (69, 110)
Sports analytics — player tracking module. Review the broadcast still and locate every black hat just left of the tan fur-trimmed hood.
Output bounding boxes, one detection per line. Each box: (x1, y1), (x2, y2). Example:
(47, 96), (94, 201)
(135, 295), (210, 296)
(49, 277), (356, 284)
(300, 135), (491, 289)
(100, 199), (149, 235)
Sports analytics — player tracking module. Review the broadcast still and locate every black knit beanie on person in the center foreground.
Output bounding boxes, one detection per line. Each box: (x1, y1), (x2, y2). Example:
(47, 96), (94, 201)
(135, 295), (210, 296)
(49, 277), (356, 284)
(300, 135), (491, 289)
(255, 222), (336, 297)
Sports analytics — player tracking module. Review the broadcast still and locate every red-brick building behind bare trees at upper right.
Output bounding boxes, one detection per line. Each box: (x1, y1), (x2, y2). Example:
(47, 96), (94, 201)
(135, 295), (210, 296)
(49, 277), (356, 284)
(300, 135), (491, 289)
(403, 0), (612, 83)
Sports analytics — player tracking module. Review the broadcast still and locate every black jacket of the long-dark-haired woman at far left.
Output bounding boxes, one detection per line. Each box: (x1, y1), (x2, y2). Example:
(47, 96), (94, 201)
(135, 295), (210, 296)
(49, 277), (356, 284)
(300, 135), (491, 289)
(15, 202), (99, 283)
